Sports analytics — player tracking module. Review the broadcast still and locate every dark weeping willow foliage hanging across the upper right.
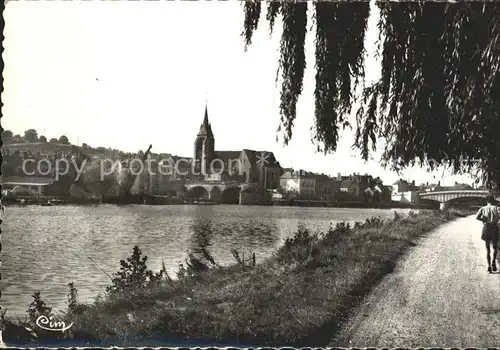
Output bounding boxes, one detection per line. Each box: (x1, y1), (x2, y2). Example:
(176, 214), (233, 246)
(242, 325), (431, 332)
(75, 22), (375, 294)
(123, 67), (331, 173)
(242, 1), (500, 189)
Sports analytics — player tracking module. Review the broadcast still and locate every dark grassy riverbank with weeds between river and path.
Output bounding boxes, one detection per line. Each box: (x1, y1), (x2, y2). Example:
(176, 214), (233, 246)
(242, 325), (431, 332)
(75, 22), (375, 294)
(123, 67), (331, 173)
(1, 211), (472, 346)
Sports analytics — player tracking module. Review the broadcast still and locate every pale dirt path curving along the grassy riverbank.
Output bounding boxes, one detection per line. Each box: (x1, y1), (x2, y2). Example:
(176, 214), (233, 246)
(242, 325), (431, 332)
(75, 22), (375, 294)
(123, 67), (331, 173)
(330, 216), (500, 347)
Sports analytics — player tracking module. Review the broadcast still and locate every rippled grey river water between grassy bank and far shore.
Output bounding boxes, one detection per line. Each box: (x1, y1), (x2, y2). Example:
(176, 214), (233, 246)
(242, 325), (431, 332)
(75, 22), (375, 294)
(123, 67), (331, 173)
(0, 205), (407, 317)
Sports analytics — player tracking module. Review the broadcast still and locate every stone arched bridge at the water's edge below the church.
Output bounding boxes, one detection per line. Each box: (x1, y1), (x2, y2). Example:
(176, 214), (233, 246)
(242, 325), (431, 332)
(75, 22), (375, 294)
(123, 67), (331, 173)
(184, 181), (259, 204)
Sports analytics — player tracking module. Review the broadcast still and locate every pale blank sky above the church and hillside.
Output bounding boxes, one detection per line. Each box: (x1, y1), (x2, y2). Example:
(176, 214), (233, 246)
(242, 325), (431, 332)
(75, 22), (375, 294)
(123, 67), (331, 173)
(2, 1), (472, 185)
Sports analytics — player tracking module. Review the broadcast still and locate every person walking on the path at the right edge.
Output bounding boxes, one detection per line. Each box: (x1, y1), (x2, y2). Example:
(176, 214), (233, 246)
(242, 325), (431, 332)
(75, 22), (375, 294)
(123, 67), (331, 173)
(476, 195), (500, 273)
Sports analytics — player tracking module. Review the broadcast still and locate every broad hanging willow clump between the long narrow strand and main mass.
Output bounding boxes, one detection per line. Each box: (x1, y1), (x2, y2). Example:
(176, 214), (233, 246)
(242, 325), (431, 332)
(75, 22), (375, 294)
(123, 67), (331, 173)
(314, 2), (370, 153)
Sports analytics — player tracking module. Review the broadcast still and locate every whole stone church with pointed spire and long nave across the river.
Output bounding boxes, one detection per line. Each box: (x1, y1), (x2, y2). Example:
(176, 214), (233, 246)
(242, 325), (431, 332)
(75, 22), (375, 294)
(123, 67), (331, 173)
(192, 106), (281, 189)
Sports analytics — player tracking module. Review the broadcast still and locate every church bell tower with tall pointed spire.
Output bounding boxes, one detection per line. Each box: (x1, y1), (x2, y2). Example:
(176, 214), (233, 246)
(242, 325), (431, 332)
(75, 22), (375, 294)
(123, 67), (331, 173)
(193, 105), (215, 175)
